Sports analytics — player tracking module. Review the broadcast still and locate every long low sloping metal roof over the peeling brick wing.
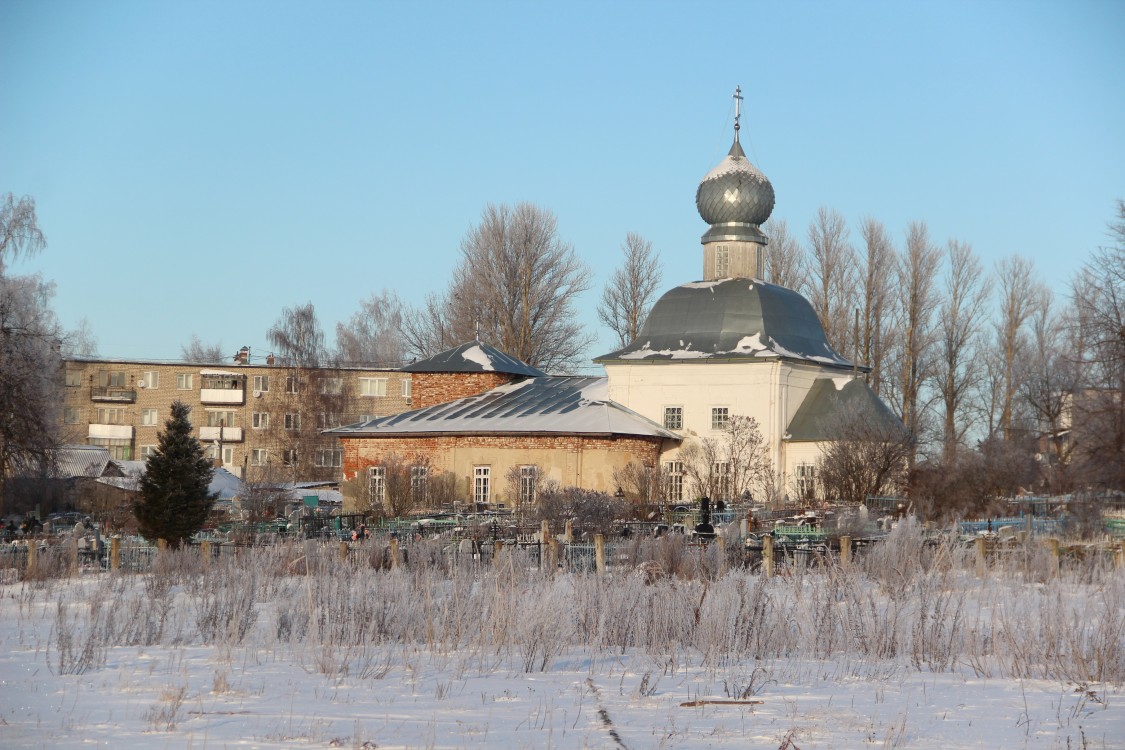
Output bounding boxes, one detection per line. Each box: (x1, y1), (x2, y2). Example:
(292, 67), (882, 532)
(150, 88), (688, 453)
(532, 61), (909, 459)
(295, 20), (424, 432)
(324, 376), (681, 440)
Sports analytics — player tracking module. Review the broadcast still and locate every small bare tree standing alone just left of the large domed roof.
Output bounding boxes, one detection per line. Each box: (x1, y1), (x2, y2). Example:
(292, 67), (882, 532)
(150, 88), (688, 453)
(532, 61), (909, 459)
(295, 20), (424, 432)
(597, 232), (662, 346)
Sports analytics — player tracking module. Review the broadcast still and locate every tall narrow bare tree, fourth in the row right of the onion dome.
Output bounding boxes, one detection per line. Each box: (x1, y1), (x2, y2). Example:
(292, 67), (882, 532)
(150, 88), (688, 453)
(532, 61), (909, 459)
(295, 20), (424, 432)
(894, 222), (942, 460)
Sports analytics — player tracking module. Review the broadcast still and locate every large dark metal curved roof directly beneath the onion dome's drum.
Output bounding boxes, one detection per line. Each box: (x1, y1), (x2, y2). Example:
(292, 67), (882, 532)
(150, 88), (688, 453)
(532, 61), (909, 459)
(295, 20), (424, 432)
(594, 279), (852, 368)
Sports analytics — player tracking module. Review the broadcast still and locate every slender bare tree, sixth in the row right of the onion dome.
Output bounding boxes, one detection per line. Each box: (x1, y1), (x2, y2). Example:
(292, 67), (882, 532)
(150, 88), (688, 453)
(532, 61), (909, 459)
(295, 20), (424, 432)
(996, 255), (1043, 441)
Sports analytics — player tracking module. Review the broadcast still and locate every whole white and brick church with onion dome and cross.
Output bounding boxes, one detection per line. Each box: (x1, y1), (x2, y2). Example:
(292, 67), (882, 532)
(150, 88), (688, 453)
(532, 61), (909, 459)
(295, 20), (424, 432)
(327, 93), (896, 507)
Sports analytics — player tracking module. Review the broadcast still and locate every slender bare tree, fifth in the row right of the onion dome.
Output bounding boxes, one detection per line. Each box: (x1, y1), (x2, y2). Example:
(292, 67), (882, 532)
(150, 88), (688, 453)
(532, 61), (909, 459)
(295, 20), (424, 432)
(935, 240), (992, 461)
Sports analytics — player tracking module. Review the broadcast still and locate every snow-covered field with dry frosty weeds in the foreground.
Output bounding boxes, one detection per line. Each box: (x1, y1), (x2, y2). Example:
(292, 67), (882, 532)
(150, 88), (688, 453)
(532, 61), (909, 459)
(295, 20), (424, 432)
(0, 530), (1125, 750)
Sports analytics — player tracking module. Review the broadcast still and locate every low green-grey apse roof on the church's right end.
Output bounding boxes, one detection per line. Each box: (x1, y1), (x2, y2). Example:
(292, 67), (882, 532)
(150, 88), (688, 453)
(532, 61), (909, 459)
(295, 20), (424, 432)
(785, 378), (906, 443)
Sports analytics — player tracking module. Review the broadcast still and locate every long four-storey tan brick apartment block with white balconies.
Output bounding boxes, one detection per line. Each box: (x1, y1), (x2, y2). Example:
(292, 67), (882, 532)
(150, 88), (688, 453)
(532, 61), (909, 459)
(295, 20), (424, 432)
(63, 359), (412, 479)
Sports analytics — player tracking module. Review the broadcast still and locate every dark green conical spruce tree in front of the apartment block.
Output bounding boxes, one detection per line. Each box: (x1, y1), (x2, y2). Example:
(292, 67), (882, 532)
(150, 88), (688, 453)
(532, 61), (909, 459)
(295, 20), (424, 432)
(133, 401), (218, 549)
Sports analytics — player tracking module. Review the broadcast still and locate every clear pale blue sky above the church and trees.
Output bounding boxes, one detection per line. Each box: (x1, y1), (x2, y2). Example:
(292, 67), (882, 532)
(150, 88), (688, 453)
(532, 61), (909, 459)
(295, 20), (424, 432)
(0, 0), (1125, 371)
